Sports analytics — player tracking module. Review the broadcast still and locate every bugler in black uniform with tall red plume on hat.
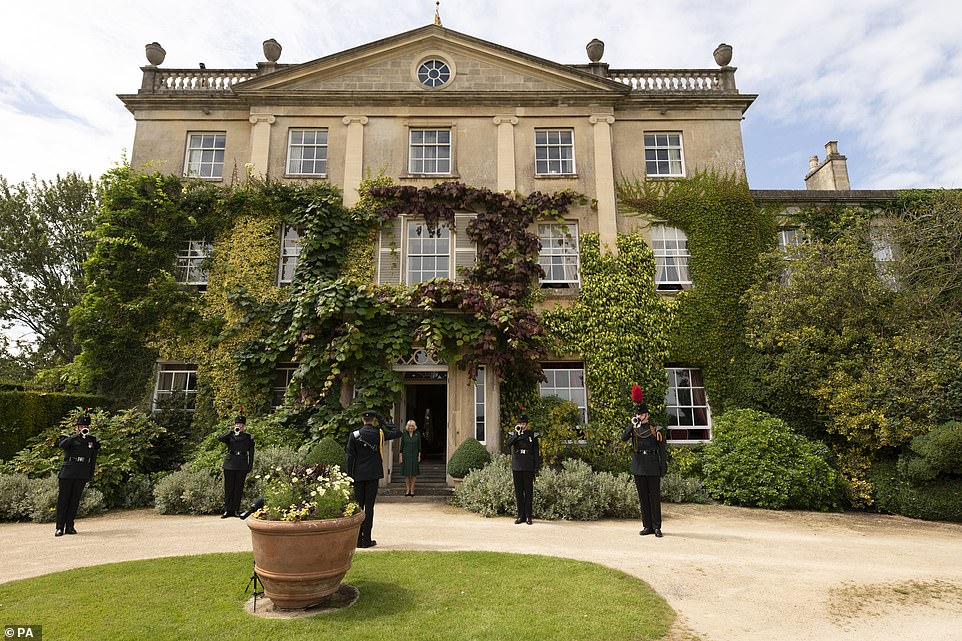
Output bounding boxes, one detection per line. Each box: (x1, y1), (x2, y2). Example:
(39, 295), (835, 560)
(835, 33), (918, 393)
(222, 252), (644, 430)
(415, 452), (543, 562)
(621, 388), (668, 538)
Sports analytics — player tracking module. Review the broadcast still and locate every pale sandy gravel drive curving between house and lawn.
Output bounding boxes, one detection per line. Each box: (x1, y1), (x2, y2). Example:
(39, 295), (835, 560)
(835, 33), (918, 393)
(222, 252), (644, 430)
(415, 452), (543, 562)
(0, 503), (962, 641)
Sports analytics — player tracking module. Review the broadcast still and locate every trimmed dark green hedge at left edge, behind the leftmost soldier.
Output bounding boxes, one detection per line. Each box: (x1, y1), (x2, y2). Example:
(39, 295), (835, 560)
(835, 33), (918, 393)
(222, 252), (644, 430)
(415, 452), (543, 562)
(0, 390), (107, 460)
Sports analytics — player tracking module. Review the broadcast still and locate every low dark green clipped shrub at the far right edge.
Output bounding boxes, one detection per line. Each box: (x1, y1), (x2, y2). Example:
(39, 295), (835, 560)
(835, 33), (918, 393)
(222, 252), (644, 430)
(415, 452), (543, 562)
(869, 461), (962, 523)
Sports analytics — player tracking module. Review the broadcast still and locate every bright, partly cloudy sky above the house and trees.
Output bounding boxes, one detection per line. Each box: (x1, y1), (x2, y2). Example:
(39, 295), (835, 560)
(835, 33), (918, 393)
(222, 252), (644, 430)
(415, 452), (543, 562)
(0, 0), (962, 189)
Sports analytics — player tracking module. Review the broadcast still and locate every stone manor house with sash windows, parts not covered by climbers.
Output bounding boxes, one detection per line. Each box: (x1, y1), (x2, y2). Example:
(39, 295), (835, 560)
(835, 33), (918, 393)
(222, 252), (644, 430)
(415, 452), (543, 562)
(120, 24), (864, 478)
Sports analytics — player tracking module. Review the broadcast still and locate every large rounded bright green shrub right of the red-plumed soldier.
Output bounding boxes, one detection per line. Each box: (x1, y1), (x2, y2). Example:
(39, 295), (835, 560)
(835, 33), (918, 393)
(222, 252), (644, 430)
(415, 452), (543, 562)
(692, 409), (837, 509)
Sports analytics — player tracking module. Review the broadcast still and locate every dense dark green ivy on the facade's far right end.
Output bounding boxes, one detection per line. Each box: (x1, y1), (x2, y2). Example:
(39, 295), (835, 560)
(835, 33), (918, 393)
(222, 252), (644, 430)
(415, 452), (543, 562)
(618, 173), (776, 412)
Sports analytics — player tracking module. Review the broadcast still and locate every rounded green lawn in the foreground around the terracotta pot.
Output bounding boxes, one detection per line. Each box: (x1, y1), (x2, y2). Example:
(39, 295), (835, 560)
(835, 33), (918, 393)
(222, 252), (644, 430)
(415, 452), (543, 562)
(0, 552), (675, 641)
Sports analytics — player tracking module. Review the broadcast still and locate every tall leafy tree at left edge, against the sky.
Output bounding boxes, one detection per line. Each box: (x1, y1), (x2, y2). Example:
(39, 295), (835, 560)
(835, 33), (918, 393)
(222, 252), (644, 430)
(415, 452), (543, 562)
(0, 173), (99, 371)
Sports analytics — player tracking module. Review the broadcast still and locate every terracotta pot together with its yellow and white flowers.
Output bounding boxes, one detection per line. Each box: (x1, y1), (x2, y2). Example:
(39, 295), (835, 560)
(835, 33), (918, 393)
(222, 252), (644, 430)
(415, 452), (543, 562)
(246, 465), (364, 609)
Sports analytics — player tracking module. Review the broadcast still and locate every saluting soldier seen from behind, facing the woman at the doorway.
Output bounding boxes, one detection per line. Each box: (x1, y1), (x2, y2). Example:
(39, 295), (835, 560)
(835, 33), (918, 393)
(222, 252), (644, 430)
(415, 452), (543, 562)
(347, 410), (401, 548)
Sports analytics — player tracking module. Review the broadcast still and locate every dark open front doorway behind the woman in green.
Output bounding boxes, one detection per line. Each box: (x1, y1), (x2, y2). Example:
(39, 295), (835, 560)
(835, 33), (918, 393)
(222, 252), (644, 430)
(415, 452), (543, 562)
(398, 372), (448, 463)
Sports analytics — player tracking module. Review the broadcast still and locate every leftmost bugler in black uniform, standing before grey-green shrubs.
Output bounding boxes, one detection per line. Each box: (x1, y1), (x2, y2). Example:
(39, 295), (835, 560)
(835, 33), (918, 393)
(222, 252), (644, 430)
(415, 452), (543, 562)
(54, 412), (100, 536)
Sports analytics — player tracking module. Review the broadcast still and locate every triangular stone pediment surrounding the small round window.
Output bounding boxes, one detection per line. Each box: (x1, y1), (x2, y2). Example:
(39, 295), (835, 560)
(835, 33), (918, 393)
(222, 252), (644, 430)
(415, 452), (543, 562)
(234, 25), (628, 96)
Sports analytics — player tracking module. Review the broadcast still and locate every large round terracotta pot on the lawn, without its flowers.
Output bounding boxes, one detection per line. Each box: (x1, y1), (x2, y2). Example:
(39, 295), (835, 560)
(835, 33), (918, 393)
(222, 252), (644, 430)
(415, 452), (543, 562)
(245, 512), (364, 610)
